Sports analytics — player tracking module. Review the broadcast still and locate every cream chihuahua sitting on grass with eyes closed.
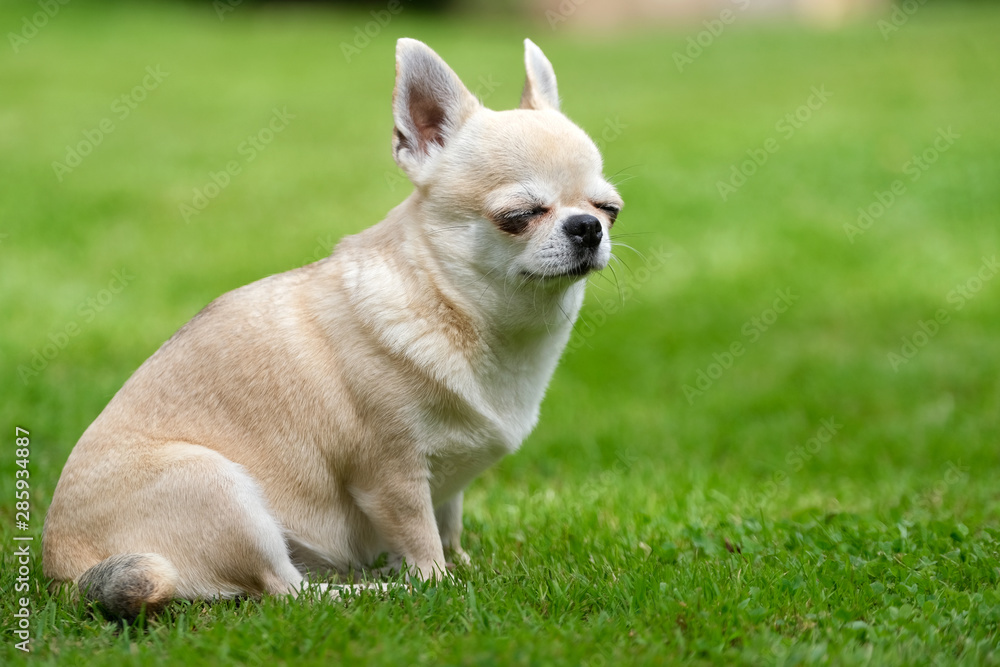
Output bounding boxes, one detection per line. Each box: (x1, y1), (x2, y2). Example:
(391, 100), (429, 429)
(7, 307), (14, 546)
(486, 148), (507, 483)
(43, 39), (622, 618)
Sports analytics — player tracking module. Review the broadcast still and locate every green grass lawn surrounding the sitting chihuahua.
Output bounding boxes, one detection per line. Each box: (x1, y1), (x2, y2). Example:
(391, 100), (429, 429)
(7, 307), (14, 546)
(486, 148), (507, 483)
(0, 3), (1000, 667)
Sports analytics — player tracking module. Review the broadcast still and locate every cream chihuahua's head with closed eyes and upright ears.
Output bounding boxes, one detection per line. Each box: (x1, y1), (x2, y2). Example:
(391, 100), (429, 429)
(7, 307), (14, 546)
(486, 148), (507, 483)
(392, 39), (622, 284)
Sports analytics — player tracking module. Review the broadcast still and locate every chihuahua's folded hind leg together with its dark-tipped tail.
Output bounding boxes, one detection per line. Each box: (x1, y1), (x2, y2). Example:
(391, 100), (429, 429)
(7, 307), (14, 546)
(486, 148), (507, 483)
(61, 443), (303, 618)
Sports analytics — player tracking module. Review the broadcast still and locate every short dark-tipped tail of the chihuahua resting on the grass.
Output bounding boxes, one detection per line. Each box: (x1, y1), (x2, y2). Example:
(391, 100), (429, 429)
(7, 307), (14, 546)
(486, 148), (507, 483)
(76, 554), (180, 621)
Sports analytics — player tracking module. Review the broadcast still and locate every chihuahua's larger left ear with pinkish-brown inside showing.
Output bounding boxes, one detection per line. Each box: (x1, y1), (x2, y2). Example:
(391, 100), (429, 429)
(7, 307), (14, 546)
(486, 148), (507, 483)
(392, 37), (481, 180)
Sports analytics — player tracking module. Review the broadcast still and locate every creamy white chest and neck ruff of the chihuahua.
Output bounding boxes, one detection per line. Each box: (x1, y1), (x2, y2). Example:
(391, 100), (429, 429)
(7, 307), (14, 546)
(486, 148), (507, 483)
(341, 244), (582, 504)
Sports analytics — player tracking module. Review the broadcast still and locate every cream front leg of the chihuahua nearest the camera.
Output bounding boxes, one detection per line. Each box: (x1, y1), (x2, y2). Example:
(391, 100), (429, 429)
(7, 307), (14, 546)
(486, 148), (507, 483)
(352, 468), (447, 580)
